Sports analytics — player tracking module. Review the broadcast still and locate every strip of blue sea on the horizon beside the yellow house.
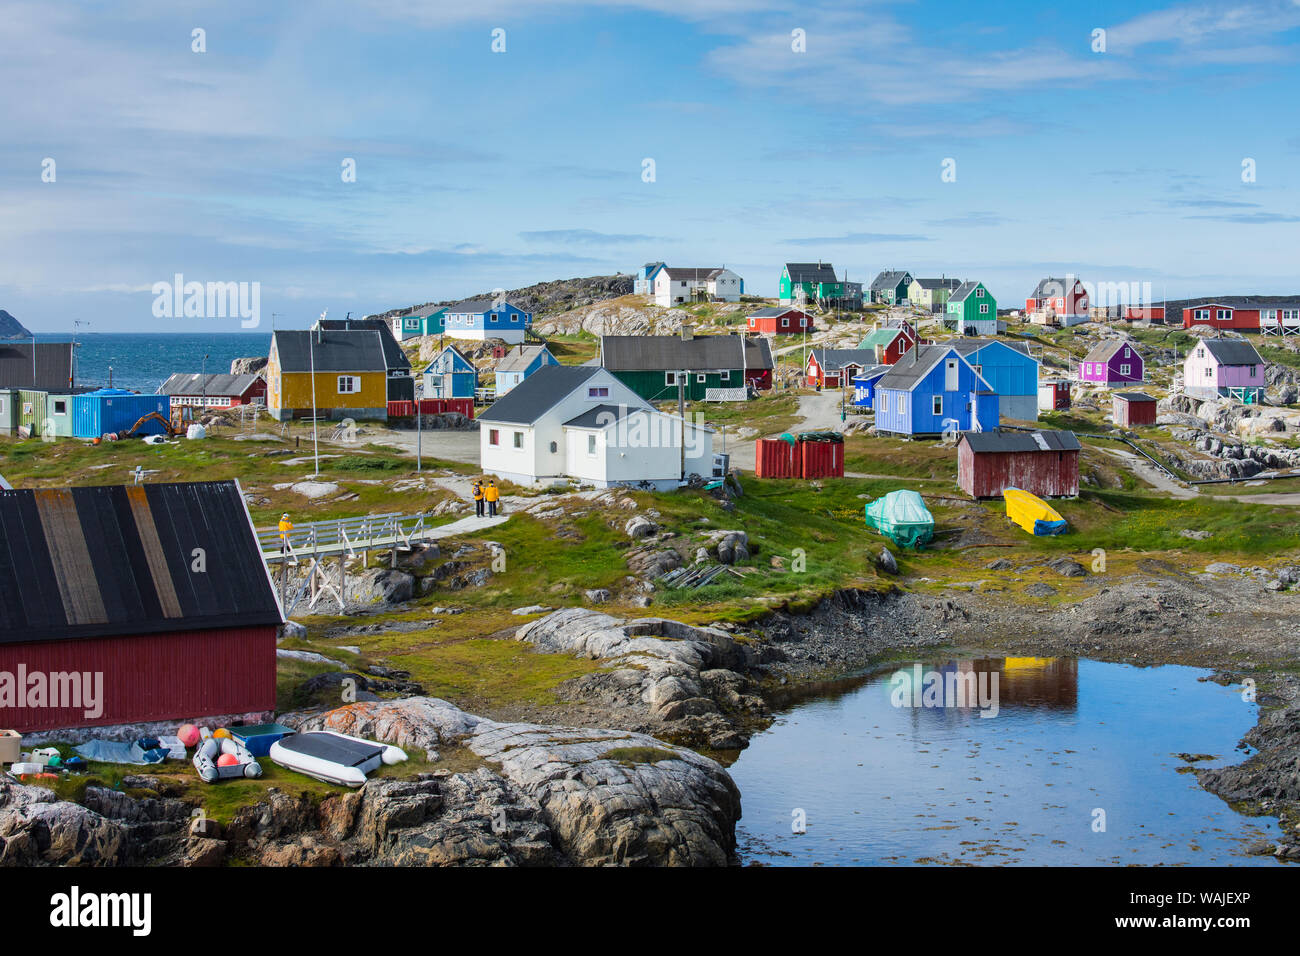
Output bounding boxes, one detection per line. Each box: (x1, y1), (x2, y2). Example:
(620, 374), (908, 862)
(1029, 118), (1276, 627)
(36, 332), (270, 393)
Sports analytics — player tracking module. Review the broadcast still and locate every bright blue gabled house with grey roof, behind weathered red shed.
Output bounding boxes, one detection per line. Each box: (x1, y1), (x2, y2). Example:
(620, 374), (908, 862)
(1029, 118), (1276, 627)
(874, 345), (997, 436)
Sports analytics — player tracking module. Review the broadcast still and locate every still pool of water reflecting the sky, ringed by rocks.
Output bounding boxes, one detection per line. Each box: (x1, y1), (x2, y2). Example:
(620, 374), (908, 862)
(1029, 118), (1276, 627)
(729, 657), (1279, 866)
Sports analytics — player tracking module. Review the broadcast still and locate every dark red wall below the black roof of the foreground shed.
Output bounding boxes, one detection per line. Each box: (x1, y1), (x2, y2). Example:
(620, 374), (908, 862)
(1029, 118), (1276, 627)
(0, 627), (276, 732)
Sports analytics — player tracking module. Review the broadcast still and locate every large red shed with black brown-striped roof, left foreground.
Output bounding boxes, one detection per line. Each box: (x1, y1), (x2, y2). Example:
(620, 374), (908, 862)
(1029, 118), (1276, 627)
(0, 481), (283, 732)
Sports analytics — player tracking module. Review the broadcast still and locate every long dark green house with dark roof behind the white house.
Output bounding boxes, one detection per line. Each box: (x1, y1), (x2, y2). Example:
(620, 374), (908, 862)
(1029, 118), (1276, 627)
(599, 328), (772, 402)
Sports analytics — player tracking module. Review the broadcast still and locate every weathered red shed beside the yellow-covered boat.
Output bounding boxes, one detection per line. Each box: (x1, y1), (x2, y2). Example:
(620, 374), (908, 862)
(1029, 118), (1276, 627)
(957, 431), (1080, 498)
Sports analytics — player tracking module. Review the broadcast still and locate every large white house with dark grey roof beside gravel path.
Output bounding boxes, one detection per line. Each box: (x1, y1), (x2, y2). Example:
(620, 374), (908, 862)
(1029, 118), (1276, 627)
(478, 365), (714, 489)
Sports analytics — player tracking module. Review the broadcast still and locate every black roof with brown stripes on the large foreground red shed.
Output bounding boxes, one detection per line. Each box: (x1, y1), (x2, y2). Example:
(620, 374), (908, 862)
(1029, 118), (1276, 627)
(0, 481), (281, 647)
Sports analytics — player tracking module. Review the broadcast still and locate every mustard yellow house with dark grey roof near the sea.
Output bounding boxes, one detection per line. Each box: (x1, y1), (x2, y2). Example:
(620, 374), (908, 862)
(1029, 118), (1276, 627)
(265, 329), (389, 421)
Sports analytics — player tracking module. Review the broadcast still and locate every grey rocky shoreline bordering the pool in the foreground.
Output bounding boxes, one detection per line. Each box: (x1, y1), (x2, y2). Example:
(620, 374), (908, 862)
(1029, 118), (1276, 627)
(0, 561), (1300, 865)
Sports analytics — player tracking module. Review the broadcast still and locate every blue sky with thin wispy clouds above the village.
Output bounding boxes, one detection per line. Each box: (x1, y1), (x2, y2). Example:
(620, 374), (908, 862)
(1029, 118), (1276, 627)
(0, 0), (1300, 332)
